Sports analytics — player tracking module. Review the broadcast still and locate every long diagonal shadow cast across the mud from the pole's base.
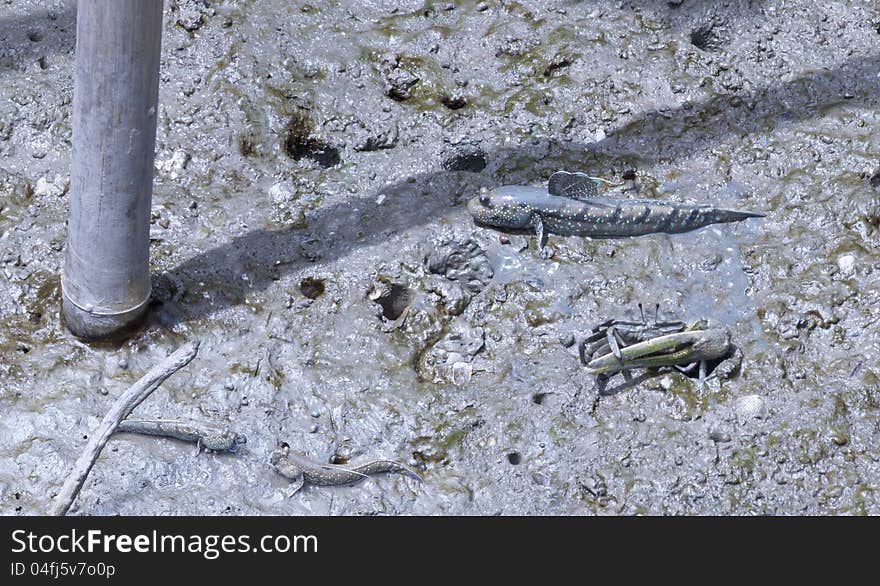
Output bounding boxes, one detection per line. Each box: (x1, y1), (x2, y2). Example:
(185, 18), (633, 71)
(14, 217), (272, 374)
(154, 51), (880, 325)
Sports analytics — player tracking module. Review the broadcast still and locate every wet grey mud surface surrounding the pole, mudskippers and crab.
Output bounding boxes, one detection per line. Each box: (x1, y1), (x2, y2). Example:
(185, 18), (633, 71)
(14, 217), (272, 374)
(0, 0), (880, 515)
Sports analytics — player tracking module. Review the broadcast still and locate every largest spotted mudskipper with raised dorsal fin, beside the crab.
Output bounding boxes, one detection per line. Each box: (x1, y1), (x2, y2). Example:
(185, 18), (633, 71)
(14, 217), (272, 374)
(468, 171), (764, 249)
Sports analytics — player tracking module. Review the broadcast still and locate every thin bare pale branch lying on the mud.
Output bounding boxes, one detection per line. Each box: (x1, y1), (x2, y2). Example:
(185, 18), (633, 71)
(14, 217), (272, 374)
(49, 341), (199, 517)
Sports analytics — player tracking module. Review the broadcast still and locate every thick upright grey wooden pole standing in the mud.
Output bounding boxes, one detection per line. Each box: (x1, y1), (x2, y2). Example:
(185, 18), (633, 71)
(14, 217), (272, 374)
(61, 0), (162, 339)
